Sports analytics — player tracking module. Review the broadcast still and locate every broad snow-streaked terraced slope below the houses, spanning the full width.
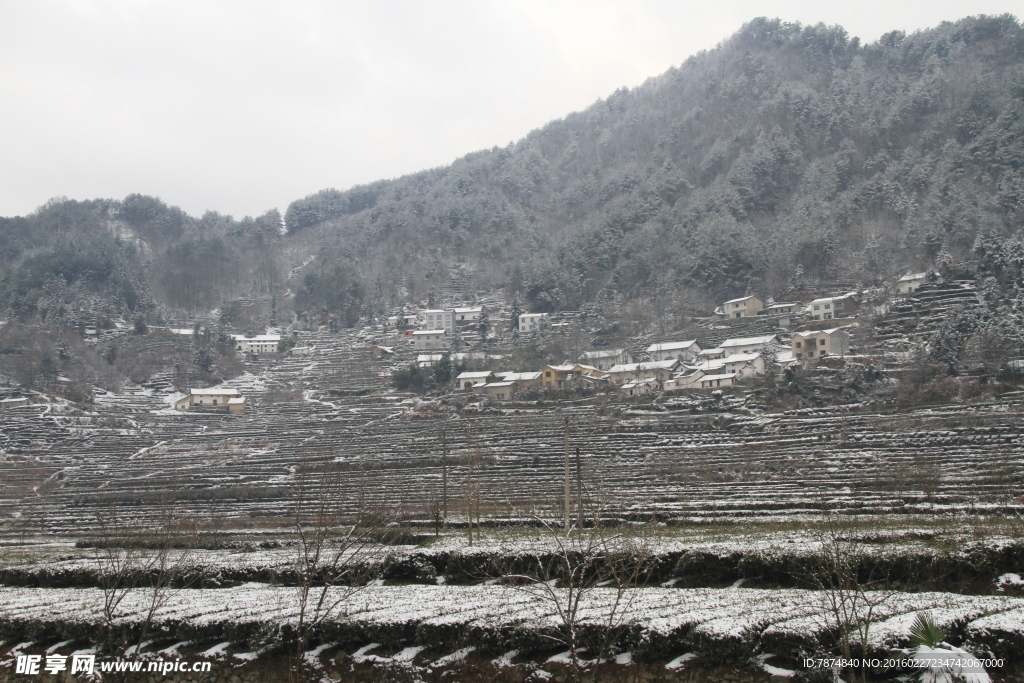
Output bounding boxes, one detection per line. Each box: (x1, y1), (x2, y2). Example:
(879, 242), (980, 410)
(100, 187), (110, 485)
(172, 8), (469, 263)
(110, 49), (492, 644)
(0, 327), (1024, 533)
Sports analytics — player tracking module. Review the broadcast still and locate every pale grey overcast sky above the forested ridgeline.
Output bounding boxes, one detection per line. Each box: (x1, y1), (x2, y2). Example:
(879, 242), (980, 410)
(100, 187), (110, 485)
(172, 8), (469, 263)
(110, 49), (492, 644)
(0, 0), (1024, 217)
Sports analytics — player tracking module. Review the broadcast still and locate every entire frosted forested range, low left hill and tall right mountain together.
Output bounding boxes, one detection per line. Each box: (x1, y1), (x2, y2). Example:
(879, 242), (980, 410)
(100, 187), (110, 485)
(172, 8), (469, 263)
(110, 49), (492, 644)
(0, 16), (1024, 327)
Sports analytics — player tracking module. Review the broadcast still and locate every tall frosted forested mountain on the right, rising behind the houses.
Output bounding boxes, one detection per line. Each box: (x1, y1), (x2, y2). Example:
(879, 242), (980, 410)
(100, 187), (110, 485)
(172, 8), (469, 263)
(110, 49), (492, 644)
(286, 16), (1024, 310)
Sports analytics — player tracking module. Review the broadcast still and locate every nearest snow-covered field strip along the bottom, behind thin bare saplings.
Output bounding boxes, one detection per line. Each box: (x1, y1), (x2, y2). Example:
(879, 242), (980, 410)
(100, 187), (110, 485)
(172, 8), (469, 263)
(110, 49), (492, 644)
(0, 584), (1024, 660)
